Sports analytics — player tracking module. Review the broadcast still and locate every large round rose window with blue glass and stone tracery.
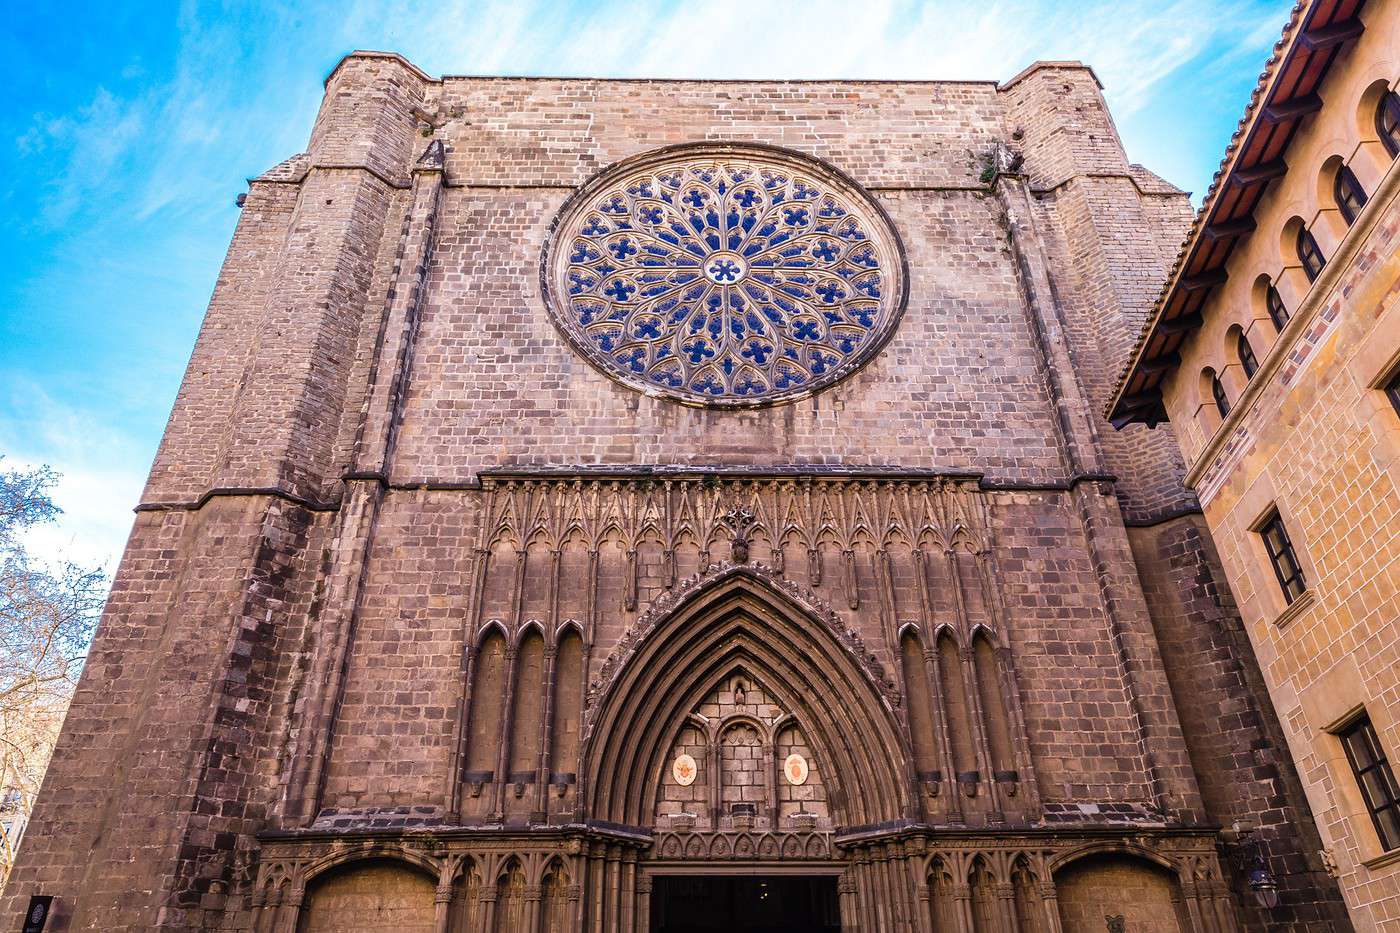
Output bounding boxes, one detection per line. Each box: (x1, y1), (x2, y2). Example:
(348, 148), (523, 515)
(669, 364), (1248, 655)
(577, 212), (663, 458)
(542, 146), (906, 406)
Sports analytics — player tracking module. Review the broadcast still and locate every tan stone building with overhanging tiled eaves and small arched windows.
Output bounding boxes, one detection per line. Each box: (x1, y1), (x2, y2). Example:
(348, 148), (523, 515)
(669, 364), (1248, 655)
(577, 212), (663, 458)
(1110, 0), (1400, 930)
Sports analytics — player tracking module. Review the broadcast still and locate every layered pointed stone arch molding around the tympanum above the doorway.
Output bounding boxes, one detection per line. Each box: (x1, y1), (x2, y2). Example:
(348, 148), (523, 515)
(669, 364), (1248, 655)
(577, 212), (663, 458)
(584, 567), (913, 827)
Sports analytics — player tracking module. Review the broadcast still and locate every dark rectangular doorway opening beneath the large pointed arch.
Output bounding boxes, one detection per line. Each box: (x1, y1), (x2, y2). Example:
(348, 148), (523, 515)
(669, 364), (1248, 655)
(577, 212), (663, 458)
(651, 874), (841, 933)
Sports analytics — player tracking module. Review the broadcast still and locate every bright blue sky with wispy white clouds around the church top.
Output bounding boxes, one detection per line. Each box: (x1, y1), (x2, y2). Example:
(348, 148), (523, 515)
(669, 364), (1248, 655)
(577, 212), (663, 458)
(0, 0), (1289, 569)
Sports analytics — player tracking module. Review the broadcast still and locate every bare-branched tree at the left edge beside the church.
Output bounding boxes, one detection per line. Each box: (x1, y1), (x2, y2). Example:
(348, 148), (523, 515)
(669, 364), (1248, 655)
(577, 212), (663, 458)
(0, 456), (106, 884)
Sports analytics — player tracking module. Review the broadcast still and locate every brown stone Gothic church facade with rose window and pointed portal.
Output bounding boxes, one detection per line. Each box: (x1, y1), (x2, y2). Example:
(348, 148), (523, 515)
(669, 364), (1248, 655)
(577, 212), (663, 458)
(3, 45), (1351, 933)
